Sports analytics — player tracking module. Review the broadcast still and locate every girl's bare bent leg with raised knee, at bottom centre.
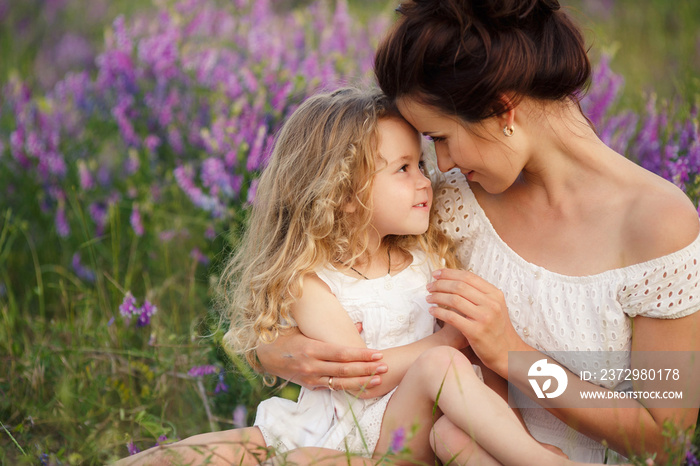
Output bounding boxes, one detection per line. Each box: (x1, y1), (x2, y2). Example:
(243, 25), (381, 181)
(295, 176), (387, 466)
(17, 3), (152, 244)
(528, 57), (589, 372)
(376, 347), (571, 466)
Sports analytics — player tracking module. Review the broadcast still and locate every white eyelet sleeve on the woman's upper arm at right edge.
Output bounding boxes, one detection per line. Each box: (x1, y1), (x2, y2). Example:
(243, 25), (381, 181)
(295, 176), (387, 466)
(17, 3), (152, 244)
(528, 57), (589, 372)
(618, 236), (700, 319)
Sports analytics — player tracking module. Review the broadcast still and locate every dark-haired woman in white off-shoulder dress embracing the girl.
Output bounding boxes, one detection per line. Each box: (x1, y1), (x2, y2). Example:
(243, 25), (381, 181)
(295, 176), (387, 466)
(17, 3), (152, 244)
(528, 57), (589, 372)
(258, 0), (700, 461)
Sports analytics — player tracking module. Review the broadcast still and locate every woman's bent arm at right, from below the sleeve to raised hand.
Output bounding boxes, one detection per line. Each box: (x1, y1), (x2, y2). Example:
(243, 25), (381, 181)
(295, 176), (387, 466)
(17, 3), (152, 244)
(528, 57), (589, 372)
(429, 270), (700, 459)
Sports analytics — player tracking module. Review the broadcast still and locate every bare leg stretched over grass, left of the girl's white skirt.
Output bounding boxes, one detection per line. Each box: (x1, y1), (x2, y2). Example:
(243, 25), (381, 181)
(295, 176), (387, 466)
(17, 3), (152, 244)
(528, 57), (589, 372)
(115, 427), (269, 466)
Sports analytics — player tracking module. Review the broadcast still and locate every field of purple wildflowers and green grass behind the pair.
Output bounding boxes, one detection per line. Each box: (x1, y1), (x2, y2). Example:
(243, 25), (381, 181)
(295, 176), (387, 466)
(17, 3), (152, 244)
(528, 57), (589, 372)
(0, 0), (700, 464)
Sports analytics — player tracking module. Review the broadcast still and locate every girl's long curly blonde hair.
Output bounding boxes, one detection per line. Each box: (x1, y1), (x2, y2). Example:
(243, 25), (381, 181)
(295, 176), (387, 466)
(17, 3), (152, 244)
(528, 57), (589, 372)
(219, 88), (459, 371)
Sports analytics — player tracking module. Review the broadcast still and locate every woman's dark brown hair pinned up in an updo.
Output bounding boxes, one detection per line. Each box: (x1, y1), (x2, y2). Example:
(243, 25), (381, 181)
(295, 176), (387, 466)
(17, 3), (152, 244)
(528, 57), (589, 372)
(375, 0), (591, 122)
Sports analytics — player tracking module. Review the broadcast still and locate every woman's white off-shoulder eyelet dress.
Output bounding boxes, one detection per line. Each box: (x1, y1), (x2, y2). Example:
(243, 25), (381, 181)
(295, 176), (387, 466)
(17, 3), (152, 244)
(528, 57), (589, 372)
(436, 170), (700, 462)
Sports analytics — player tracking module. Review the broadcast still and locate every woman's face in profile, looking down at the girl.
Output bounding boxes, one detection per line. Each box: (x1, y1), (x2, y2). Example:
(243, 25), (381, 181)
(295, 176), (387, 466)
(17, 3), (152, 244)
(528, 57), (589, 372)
(397, 97), (524, 194)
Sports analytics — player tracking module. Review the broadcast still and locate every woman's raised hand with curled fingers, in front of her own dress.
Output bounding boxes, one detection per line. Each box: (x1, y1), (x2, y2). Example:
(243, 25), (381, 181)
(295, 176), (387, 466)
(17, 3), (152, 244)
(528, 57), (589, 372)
(428, 269), (530, 378)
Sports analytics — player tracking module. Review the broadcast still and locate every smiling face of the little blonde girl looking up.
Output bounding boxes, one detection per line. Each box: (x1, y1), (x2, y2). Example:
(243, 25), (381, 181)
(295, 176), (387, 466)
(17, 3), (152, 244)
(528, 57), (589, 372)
(372, 118), (433, 238)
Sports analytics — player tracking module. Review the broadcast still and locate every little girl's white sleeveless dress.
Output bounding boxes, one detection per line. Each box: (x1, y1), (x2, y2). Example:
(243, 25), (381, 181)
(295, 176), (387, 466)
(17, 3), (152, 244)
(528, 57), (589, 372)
(255, 251), (435, 457)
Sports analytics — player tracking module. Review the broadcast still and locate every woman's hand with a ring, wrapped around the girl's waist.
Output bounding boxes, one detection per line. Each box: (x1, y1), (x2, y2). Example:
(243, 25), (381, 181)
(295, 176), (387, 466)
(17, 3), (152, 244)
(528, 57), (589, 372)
(257, 329), (388, 391)
